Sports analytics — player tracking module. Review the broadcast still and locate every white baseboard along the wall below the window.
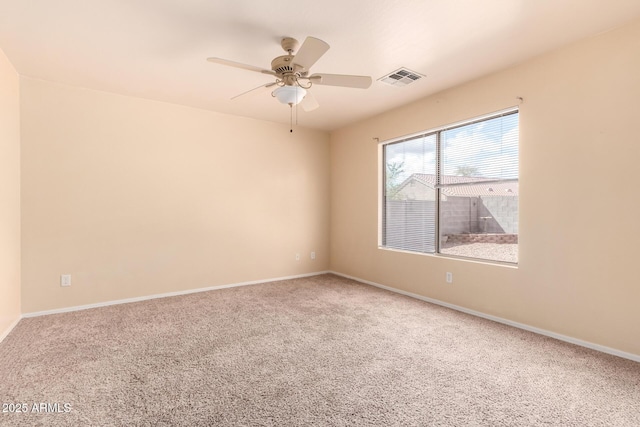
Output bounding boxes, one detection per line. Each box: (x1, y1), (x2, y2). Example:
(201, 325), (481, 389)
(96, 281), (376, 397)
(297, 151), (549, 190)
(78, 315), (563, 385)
(330, 271), (640, 362)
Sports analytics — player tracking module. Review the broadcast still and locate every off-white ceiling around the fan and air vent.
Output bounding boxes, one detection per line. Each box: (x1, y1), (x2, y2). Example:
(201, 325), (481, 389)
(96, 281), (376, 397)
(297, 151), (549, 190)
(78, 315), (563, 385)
(0, 0), (640, 130)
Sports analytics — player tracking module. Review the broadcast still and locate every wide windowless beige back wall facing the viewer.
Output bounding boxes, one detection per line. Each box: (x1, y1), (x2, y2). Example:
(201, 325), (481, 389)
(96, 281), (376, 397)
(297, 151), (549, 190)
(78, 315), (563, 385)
(21, 77), (330, 313)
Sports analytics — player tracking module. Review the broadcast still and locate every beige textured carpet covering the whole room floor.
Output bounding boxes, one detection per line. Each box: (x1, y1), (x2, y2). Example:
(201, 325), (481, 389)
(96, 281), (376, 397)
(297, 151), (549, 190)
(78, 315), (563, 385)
(0, 275), (640, 427)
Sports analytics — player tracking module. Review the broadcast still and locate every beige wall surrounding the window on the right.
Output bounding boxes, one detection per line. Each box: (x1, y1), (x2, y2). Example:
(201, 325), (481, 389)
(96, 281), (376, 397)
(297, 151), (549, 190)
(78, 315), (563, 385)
(331, 21), (640, 355)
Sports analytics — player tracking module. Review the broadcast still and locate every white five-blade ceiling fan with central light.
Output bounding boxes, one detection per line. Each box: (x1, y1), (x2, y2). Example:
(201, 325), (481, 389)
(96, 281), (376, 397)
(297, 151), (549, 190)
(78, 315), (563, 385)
(207, 37), (371, 111)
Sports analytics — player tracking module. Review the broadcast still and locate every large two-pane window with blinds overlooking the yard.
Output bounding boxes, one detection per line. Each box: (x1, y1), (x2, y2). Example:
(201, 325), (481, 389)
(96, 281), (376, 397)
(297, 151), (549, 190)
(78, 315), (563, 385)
(381, 109), (519, 263)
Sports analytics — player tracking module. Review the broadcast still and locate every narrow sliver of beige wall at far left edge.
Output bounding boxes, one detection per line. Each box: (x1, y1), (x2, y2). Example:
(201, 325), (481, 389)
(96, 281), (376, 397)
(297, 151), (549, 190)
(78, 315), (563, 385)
(0, 50), (20, 339)
